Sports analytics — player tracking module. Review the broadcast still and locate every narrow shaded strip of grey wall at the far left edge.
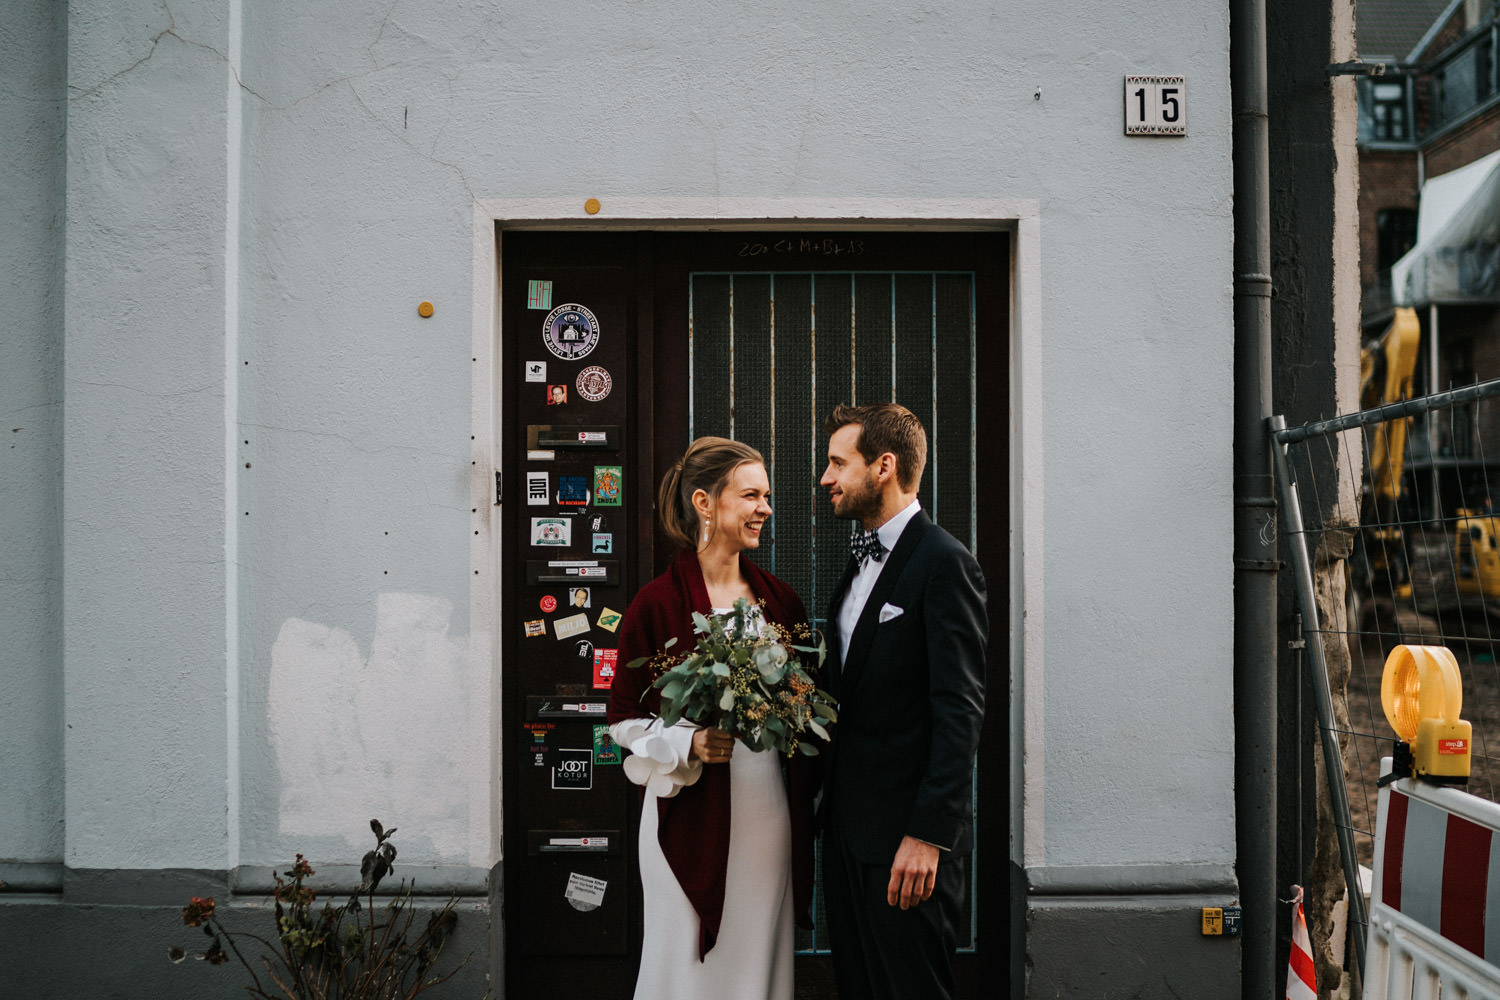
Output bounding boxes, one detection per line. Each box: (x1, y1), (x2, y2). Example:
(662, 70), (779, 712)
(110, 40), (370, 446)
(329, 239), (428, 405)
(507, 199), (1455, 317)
(0, 0), (68, 885)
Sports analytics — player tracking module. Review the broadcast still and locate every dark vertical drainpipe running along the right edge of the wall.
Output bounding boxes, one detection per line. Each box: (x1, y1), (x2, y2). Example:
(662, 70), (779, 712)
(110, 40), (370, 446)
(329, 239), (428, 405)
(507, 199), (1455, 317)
(1230, 0), (1280, 1000)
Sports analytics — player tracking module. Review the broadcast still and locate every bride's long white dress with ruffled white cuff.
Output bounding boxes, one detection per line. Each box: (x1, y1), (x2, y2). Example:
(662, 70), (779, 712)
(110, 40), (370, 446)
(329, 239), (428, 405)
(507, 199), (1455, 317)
(611, 611), (795, 1000)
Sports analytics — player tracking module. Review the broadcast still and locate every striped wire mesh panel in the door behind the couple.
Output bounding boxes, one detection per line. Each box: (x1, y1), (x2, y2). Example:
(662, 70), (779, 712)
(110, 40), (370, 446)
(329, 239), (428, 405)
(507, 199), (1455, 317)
(689, 271), (977, 951)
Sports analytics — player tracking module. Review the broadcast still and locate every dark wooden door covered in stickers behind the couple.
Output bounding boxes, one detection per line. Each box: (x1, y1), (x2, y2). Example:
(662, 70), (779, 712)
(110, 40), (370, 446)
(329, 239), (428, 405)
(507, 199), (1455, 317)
(500, 232), (1020, 997)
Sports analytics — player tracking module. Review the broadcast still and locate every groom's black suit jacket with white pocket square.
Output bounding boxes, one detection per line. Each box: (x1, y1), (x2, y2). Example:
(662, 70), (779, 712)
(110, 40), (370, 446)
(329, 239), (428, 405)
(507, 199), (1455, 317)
(822, 511), (989, 865)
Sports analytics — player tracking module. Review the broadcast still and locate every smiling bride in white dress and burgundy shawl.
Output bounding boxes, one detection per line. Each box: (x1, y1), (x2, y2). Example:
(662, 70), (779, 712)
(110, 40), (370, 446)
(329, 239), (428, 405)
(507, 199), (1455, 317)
(609, 438), (821, 1000)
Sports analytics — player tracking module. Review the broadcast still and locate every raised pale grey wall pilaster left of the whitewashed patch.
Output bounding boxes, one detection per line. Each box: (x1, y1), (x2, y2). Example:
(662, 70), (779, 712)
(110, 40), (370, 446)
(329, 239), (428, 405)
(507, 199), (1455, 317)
(63, 3), (233, 870)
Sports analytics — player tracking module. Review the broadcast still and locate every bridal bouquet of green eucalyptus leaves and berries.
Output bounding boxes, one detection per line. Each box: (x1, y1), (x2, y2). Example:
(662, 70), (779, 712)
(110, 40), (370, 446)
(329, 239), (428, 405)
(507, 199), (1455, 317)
(627, 597), (839, 757)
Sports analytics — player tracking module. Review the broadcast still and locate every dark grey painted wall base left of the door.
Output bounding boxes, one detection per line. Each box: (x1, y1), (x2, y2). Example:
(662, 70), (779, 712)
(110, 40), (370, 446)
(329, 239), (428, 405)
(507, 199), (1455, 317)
(0, 871), (503, 1000)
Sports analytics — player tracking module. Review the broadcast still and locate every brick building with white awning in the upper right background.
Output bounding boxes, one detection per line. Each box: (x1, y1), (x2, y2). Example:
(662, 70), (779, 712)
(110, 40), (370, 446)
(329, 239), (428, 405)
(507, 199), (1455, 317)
(1356, 0), (1500, 508)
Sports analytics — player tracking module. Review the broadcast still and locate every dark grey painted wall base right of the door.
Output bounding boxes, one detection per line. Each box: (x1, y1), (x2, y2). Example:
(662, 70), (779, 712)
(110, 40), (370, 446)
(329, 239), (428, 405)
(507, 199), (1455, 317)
(1026, 894), (1241, 1000)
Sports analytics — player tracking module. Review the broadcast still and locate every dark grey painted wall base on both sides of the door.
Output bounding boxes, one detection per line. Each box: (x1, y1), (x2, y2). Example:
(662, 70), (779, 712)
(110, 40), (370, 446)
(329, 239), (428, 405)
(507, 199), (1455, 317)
(0, 870), (1241, 1000)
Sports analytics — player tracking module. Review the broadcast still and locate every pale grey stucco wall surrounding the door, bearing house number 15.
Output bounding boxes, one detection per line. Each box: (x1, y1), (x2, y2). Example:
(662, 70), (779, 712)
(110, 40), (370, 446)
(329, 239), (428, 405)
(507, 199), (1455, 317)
(35, 0), (1235, 887)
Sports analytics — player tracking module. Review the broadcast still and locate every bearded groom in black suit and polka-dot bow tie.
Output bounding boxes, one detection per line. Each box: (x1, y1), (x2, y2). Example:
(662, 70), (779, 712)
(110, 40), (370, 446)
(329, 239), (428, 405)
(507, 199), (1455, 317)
(819, 403), (989, 1000)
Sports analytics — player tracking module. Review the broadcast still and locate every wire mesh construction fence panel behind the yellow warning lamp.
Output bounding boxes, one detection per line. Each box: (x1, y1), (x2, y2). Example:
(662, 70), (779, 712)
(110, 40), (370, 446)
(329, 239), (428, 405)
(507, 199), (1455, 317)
(1274, 374), (1500, 971)
